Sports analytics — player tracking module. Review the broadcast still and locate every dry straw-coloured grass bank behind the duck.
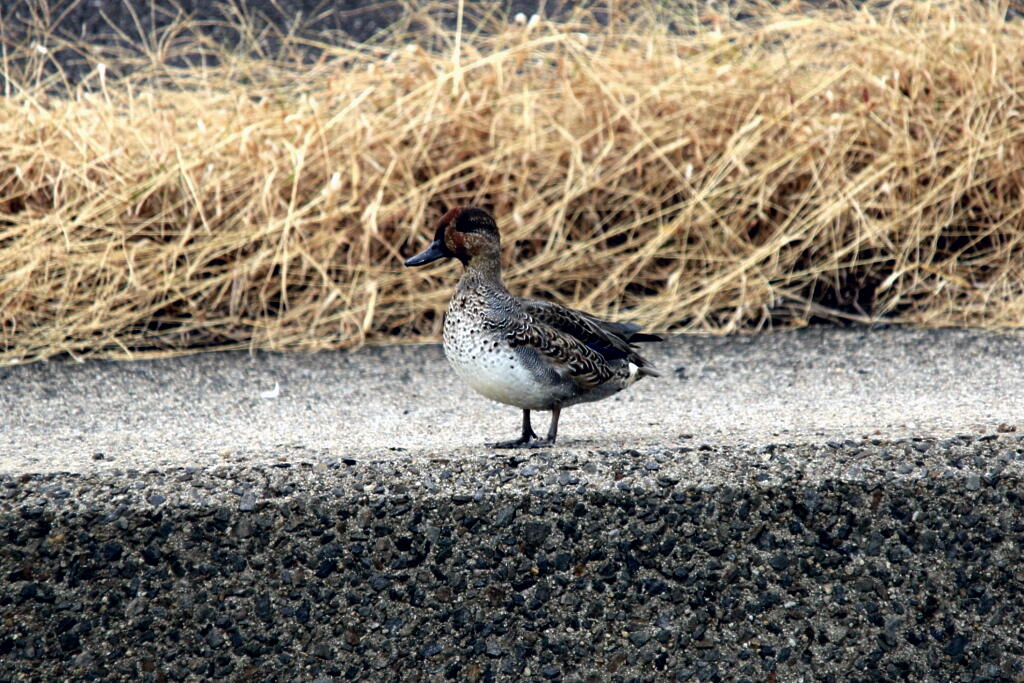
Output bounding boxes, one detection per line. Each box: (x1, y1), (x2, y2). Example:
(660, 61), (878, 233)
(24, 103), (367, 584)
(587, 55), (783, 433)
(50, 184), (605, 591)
(0, 1), (1024, 362)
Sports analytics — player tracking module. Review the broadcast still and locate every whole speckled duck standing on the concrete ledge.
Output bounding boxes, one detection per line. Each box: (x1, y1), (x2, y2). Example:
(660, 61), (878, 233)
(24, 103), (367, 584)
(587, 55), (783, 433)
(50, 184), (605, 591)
(404, 206), (663, 449)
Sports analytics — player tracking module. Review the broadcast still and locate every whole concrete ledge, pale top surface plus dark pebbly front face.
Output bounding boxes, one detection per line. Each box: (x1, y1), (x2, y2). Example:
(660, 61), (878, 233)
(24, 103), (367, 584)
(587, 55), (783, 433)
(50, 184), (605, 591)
(0, 330), (1024, 681)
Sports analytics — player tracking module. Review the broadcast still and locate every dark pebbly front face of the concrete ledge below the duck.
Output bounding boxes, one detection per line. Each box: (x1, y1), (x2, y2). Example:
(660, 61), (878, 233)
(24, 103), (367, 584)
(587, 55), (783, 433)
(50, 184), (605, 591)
(0, 433), (1024, 681)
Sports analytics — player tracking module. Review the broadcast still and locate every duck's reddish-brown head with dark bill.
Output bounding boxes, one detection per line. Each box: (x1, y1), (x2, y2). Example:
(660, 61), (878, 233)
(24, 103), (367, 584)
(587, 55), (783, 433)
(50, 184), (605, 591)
(406, 206), (501, 266)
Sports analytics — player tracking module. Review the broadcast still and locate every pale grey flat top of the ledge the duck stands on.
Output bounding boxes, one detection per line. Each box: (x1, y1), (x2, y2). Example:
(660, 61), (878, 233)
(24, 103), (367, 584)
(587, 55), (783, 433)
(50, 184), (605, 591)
(0, 329), (1024, 472)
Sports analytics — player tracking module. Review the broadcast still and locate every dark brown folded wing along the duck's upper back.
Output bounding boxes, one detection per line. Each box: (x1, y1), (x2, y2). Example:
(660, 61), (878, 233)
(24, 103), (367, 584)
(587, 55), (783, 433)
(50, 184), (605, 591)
(521, 299), (662, 368)
